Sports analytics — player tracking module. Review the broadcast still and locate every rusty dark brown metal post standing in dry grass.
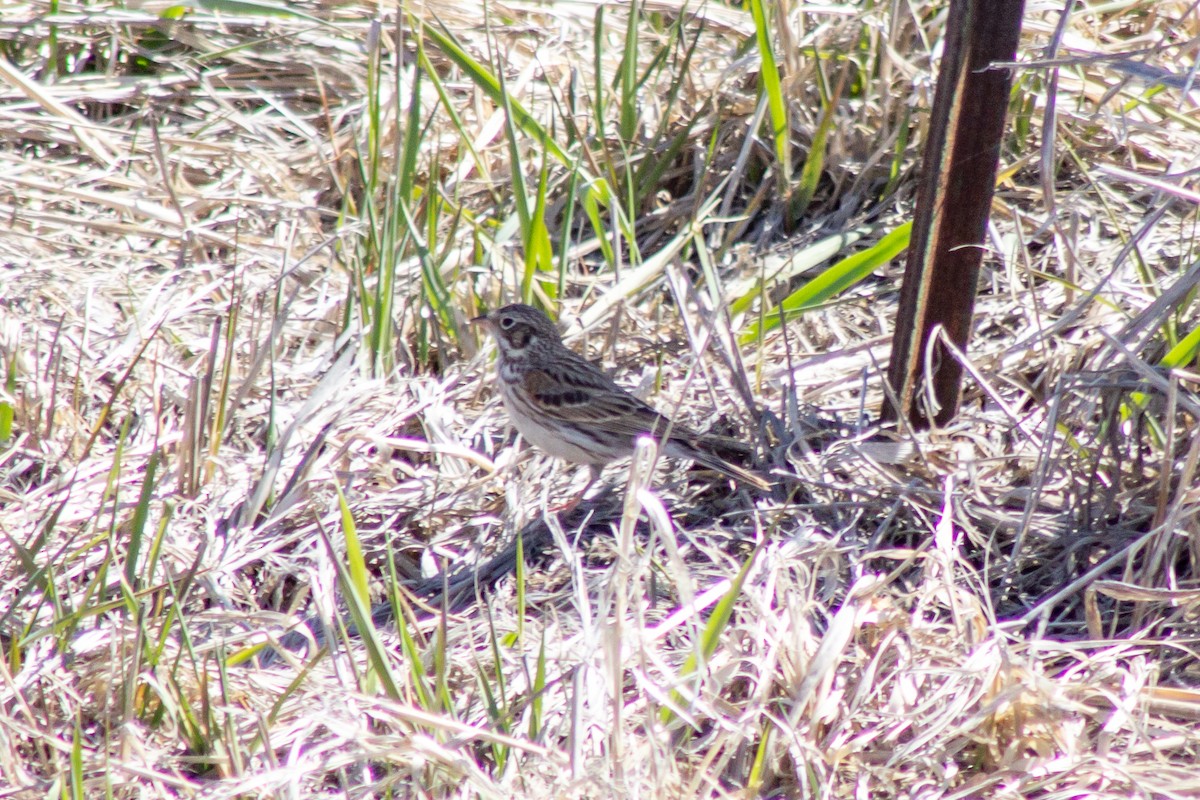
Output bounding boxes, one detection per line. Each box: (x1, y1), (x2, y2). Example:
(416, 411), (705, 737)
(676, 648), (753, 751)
(883, 0), (1025, 428)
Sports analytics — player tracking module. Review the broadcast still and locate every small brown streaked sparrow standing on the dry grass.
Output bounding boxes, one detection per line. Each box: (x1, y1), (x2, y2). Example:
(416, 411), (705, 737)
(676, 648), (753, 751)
(472, 303), (770, 497)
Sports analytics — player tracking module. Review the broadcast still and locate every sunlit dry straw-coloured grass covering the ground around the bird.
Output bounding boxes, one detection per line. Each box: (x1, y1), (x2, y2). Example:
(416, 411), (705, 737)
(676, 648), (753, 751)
(0, 0), (1200, 798)
